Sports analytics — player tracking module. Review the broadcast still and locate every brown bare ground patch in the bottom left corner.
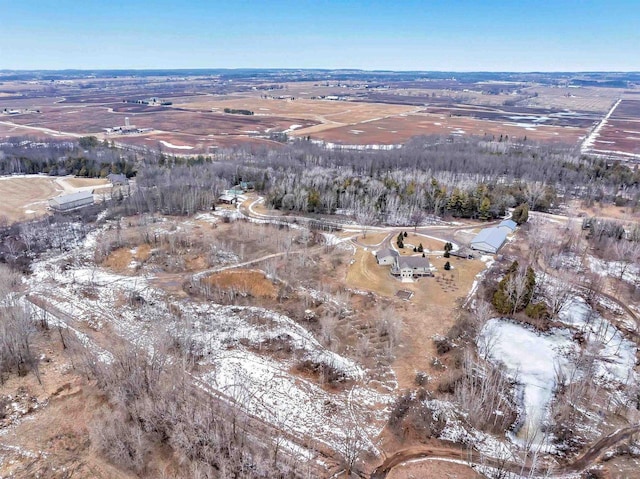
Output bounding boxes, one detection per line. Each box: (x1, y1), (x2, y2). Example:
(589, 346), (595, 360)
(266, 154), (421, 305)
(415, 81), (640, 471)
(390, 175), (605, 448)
(0, 331), (134, 479)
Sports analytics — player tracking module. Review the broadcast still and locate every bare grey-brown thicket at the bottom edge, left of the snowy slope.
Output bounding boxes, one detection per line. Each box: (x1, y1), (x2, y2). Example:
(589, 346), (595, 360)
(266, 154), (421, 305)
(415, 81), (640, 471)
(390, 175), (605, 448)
(88, 347), (297, 478)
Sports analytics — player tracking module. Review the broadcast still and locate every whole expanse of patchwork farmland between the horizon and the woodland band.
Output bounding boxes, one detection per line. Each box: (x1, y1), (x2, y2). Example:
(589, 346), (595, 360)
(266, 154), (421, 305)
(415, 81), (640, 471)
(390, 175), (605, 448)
(0, 72), (637, 155)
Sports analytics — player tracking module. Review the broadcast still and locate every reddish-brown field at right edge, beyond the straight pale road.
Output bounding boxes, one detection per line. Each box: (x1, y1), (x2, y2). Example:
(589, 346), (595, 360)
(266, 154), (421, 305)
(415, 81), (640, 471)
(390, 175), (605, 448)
(591, 100), (640, 159)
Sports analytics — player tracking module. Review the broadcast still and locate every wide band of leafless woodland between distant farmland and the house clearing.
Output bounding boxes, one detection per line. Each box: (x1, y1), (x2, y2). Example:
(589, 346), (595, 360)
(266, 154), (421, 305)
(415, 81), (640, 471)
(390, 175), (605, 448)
(5, 137), (640, 225)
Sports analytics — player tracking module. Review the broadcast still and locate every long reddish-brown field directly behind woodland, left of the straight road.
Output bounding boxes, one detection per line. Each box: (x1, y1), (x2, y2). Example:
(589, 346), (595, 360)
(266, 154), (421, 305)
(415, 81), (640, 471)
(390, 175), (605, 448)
(310, 114), (588, 145)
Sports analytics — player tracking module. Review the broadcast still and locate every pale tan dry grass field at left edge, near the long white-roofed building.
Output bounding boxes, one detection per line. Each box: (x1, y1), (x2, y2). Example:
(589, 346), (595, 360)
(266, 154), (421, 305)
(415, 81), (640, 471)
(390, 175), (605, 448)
(0, 176), (60, 223)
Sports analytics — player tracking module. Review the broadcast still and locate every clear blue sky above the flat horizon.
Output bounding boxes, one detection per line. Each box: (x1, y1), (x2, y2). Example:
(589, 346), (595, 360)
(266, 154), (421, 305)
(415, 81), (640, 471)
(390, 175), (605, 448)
(0, 0), (640, 71)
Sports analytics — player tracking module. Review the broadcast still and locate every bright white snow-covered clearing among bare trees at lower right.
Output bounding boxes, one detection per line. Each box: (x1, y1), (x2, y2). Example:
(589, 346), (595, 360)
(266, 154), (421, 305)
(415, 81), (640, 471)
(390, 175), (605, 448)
(478, 297), (637, 448)
